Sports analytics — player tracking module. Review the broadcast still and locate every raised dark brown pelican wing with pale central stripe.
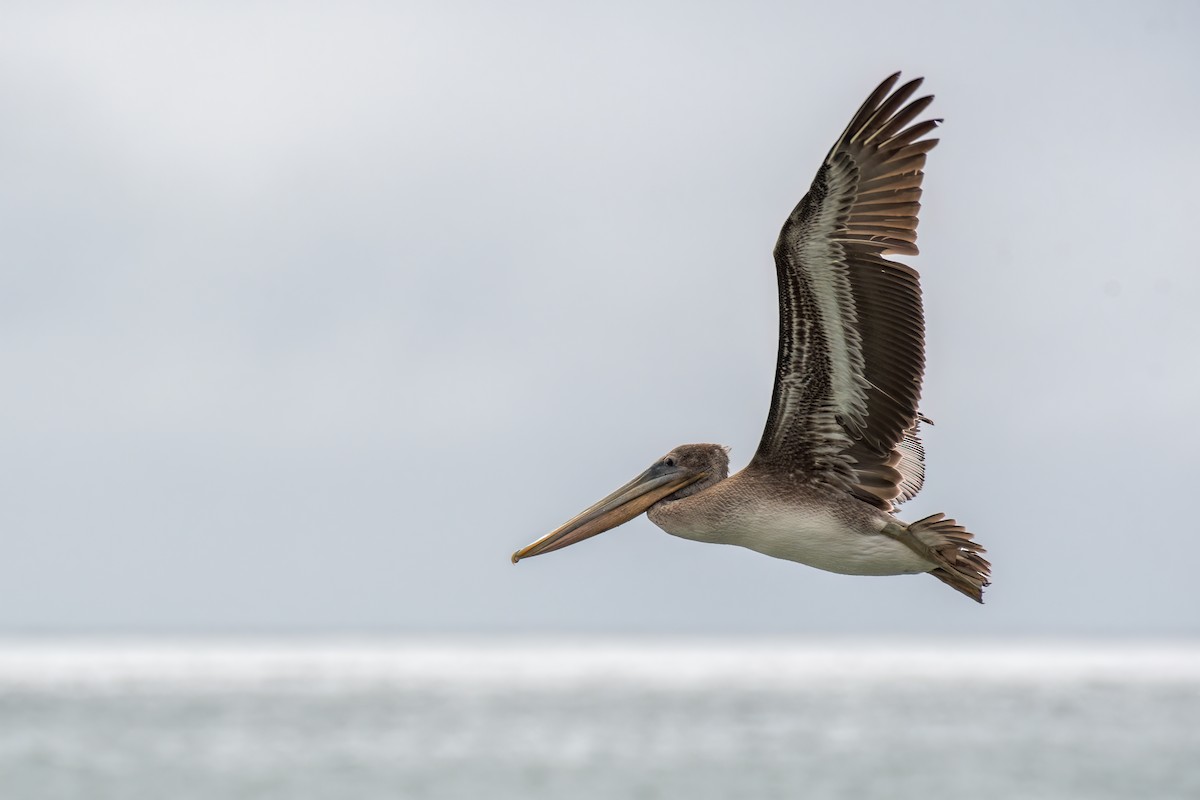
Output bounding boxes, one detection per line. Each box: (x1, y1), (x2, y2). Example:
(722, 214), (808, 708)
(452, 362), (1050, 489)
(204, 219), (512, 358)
(751, 73), (941, 510)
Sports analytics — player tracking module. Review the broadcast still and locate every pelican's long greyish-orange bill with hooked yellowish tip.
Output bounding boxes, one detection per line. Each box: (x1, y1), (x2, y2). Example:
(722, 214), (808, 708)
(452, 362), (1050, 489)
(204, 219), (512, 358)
(512, 463), (708, 564)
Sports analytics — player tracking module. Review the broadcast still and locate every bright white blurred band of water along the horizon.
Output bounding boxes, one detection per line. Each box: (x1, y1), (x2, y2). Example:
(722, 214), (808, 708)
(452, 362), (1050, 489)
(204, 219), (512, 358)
(0, 639), (1200, 691)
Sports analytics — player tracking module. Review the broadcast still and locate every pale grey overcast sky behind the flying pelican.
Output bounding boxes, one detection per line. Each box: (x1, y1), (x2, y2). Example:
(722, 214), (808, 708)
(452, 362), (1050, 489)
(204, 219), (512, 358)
(0, 0), (1200, 636)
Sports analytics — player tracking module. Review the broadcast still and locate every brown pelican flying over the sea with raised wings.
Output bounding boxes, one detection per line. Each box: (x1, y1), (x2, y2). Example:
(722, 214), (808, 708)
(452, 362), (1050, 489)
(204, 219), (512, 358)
(512, 73), (990, 602)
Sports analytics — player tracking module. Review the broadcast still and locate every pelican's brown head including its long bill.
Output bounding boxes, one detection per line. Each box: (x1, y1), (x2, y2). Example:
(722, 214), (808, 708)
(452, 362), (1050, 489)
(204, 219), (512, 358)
(512, 444), (730, 564)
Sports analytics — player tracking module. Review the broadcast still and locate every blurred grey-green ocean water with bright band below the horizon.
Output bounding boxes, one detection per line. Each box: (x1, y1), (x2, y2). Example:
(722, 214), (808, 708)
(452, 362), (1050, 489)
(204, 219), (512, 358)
(0, 639), (1200, 800)
